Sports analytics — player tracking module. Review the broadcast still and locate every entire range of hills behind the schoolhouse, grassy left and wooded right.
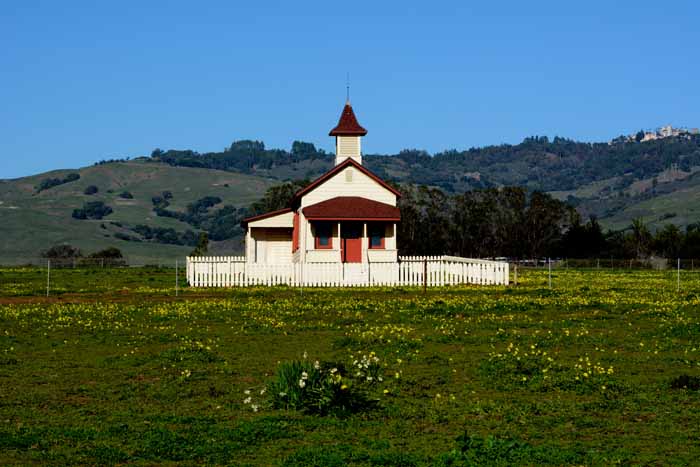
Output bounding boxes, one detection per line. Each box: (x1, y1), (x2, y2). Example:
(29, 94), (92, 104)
(0, 135), (700, 264)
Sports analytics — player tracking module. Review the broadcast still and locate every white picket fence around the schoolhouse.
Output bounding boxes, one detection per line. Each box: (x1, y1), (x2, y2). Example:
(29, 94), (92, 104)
(187, 256), (510, 287)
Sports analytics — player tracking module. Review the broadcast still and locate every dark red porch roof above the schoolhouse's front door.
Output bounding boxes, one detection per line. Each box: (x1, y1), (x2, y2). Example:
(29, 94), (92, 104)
(302, 196), (401, 221)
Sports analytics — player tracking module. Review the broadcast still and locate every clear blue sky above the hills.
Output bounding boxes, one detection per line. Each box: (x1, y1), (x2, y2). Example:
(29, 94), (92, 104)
(0, 0), (700, 178)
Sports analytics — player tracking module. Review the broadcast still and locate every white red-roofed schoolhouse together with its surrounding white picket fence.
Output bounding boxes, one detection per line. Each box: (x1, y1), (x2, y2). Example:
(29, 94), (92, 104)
(187, 101), (508, 286)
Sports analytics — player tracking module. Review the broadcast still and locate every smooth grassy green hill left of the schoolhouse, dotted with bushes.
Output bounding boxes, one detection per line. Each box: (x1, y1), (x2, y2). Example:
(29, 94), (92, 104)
(0, 160), (275, 264)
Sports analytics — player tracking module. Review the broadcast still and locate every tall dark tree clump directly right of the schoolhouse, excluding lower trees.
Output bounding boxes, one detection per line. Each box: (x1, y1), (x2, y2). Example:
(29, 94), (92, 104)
(398, 186), (577, 258)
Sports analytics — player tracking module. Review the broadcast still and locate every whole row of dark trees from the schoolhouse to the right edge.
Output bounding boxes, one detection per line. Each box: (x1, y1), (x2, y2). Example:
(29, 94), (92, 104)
(398, 186), (700, 259)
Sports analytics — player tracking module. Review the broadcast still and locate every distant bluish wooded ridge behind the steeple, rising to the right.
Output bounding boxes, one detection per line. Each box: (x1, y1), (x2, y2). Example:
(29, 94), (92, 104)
(151, 134), (700, 229)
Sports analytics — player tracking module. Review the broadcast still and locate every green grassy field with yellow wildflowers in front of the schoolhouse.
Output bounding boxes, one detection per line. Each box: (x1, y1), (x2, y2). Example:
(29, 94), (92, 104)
(0, 268), (700, 466)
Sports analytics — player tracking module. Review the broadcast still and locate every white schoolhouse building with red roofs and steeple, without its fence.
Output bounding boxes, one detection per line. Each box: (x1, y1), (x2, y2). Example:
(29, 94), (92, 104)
(242, 101), (401, 265)
